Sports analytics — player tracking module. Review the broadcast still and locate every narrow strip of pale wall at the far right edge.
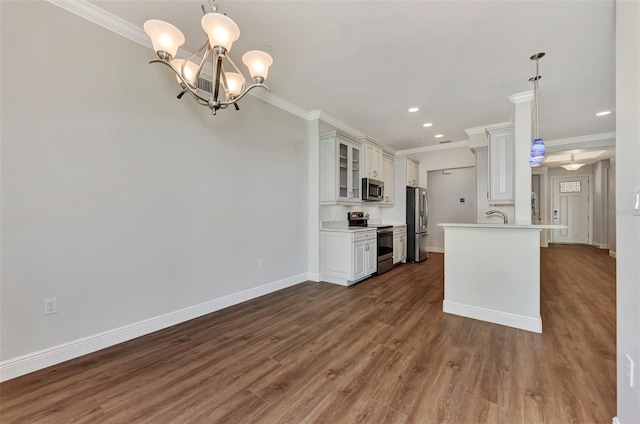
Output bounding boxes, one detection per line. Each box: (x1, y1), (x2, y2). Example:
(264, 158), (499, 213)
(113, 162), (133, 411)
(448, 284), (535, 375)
(615, 0), (640, 424)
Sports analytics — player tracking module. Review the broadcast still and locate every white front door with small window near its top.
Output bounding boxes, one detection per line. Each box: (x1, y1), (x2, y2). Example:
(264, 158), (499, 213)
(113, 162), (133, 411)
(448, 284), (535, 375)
(551, 176), (589, 244)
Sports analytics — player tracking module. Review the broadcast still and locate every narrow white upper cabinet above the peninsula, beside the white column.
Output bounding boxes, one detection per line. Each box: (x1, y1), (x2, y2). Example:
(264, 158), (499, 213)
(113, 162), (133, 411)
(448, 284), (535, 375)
(487, 124), (515, 205)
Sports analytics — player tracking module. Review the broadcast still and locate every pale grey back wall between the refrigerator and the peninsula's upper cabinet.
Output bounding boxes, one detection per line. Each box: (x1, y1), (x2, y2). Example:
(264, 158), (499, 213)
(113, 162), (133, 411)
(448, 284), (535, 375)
(427, 167), (476, 252)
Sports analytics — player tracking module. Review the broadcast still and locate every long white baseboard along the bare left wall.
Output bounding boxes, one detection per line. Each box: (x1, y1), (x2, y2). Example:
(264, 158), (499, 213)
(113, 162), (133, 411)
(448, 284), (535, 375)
(0, 273), (309, 381)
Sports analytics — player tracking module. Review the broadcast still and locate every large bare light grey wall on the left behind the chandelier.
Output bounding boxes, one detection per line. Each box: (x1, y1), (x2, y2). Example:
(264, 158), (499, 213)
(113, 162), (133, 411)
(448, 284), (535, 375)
(0, 2), (308, 368)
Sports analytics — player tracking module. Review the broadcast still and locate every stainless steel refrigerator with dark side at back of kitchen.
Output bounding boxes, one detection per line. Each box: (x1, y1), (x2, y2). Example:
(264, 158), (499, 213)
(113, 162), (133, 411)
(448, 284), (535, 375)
(407, 187), (429, 262)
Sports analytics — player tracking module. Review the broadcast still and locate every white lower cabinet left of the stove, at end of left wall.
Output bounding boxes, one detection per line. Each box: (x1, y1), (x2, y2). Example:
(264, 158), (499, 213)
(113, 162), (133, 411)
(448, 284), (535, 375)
(320, 230), (378, 286)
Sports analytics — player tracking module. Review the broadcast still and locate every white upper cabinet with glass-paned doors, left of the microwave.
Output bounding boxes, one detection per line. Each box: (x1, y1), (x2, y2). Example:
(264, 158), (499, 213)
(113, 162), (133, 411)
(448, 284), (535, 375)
(319, 131), (363, 205)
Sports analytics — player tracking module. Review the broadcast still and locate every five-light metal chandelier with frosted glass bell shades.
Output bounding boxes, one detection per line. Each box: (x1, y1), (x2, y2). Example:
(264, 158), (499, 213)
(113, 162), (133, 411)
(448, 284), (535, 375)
(144, 0), (273, 115)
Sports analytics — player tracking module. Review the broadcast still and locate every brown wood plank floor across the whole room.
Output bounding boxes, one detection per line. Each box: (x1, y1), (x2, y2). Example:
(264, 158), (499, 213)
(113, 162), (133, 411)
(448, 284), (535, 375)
(0, 245), (616, 424)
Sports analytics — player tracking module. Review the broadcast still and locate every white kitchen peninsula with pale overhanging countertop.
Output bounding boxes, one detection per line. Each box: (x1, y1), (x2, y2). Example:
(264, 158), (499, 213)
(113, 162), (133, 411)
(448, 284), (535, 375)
(438, 223), (566, 333)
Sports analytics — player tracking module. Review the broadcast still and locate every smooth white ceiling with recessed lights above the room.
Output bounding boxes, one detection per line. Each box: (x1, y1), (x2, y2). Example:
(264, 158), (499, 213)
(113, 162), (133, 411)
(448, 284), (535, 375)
(91, 0), (615, 150)
